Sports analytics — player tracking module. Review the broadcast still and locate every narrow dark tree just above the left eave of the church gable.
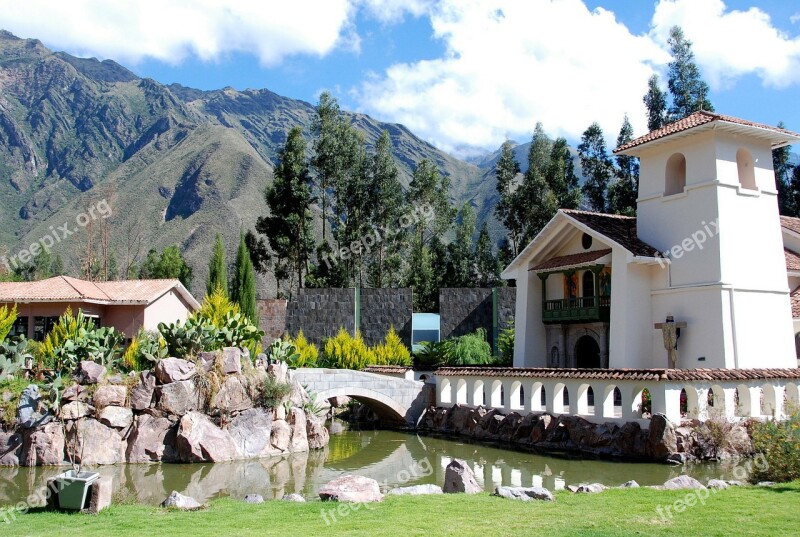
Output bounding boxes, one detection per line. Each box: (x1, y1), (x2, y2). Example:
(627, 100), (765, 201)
(494, 140), (525, 257)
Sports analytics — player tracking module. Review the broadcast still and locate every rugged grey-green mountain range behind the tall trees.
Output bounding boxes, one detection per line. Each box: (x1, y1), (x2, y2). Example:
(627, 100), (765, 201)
(0, 31), (494, 295)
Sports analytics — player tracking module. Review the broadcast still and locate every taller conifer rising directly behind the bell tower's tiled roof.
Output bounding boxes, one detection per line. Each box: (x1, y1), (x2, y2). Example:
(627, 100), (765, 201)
(667, 26), (714, 121)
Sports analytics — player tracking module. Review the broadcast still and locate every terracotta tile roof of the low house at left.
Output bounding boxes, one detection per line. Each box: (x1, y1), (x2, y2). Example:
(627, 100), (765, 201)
(0, 276), (199, 308)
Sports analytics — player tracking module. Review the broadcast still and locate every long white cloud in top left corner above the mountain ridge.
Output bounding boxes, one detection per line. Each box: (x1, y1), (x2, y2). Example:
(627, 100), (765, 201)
(0, 0), (358, 66)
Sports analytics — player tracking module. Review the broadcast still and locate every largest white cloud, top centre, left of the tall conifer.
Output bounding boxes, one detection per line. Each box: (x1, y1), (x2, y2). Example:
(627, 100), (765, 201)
(359, 0), (668, 153)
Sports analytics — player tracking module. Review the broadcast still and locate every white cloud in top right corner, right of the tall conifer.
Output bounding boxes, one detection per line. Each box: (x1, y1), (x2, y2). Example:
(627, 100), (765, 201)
(651, 0), (800, 89)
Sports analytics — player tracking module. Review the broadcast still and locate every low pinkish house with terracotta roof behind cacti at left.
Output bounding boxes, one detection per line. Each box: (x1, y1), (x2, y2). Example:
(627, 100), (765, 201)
(0, 276), (200, 340)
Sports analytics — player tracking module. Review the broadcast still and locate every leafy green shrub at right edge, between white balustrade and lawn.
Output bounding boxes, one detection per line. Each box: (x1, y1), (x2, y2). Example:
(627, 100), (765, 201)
(750, 409), (800, 482)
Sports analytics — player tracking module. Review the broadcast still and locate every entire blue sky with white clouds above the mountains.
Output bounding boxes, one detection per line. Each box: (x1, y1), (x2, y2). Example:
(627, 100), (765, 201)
(0, 0), (800, 156)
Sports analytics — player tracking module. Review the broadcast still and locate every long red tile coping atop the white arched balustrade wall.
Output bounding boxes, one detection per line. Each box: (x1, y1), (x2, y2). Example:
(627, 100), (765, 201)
(436, 367), (800, 382)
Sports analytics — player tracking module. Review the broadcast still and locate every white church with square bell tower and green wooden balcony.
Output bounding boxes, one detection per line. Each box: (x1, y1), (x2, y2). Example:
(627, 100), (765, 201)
(503, 111), (800, 369)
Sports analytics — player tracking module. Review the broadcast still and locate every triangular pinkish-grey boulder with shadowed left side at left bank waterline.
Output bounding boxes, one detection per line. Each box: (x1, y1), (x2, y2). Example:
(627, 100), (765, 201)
(175, 412), (240, 462)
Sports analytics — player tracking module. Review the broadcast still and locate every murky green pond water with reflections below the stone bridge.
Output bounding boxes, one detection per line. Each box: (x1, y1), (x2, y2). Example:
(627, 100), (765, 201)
(0, 423), (752, 505)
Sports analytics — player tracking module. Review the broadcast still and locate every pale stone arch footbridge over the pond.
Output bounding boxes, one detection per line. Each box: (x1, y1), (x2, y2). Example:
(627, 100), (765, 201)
(292, 368), (435, 428)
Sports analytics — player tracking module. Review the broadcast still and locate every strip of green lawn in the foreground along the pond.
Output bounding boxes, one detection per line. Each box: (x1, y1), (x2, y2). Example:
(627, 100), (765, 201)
(0, 481), (800, 537)
